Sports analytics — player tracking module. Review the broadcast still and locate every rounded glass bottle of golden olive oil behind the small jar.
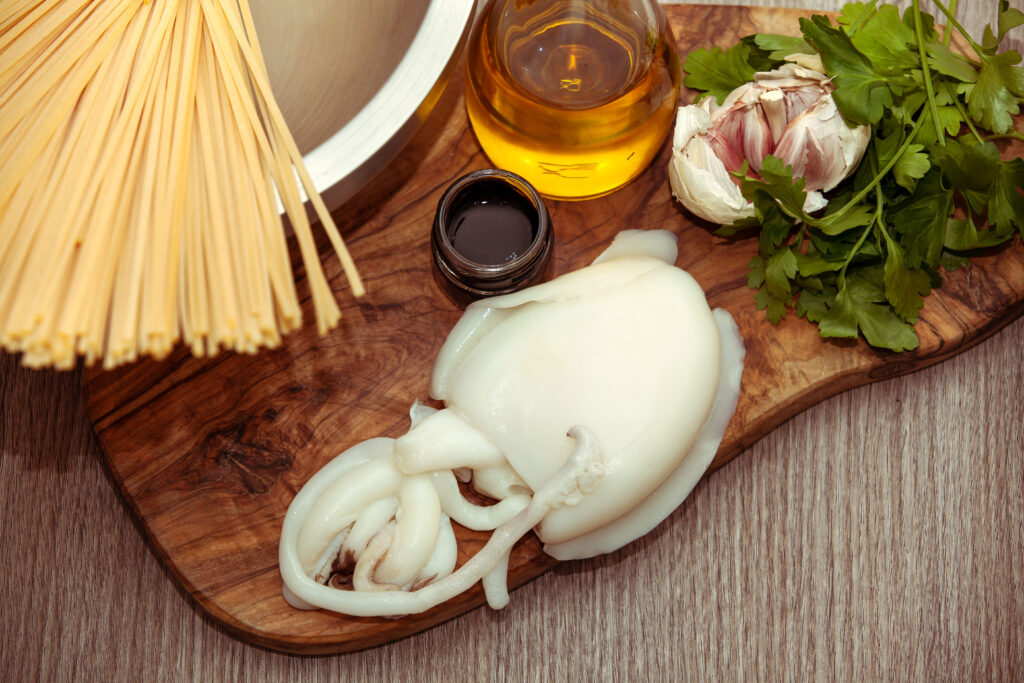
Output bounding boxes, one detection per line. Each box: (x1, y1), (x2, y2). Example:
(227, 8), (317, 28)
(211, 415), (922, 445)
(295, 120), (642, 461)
(466, 0), (680, 199)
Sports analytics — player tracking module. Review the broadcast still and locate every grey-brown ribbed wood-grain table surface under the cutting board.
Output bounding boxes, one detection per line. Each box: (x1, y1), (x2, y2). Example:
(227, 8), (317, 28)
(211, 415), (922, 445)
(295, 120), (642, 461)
(0, 0), (1024, 681)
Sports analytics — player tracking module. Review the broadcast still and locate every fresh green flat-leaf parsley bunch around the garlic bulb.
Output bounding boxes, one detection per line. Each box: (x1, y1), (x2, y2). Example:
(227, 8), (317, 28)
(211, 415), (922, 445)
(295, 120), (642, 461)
(684, 0), (1024, 351)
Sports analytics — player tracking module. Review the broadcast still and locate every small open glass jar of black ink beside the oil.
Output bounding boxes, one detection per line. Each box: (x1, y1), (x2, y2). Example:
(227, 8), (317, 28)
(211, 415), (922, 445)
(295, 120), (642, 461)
(430, 169), (554, 307)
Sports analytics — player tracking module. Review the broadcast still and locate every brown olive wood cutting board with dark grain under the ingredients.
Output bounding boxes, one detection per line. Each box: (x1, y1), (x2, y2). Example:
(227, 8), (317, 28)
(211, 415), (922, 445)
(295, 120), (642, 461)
(86, 5), (1024, 653)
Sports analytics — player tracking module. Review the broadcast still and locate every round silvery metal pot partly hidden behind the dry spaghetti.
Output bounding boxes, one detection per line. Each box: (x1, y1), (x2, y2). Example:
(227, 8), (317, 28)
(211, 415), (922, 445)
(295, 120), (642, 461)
(251, 0), (475, 208)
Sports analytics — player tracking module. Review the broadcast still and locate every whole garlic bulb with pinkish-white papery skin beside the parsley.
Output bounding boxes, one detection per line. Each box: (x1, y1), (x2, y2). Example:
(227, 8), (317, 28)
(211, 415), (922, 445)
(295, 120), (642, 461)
(669, 59), (870, 224)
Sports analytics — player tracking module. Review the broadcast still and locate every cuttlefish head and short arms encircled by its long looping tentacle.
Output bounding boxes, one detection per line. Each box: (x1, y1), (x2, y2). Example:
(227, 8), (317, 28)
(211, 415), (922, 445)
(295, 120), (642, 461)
(298, 404), (529, 602)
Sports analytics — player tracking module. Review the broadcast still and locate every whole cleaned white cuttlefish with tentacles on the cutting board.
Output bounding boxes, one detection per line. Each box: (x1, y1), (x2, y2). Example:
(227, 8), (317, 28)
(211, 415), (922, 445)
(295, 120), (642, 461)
(279, 230), (744, 616)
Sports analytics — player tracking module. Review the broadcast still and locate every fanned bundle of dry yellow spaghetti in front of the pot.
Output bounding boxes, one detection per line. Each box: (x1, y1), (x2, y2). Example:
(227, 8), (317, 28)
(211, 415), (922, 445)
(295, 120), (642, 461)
(0, 0), (362, 368)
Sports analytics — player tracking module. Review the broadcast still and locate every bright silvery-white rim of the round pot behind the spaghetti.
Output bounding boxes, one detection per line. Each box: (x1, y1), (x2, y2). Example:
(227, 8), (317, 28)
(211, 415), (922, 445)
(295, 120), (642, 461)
(294, 0), (476, 205)
